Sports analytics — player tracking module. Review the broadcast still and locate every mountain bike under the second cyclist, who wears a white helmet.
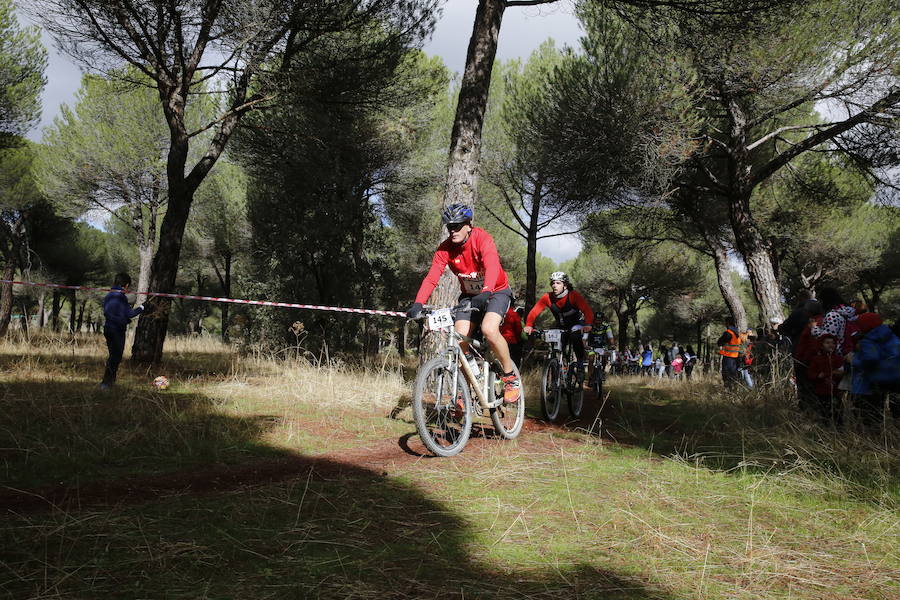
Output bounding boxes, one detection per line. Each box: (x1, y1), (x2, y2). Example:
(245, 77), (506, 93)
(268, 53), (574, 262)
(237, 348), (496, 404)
(535, 325), (584, 421)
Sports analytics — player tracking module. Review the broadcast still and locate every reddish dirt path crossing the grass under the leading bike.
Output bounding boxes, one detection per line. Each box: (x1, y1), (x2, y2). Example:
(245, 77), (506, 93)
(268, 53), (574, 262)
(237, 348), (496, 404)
(0, 393), (597, 514)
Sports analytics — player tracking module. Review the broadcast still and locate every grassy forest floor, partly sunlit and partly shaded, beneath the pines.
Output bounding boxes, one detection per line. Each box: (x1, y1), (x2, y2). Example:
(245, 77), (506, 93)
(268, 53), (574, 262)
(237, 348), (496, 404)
(0, 337), (900, 600)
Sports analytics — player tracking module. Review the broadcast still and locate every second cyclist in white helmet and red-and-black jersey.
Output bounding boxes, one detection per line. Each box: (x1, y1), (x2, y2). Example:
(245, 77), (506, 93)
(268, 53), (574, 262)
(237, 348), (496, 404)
(525, 271), (594, 380)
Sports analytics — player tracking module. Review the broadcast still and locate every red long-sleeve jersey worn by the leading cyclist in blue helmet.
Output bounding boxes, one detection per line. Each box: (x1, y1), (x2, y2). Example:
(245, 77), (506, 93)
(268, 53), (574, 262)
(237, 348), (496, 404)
(416, 227), (509, 304)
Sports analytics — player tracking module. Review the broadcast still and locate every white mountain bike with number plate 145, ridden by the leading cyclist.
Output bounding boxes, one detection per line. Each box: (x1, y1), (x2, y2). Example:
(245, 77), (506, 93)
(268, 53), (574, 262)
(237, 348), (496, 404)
(412, 303), (525, 456)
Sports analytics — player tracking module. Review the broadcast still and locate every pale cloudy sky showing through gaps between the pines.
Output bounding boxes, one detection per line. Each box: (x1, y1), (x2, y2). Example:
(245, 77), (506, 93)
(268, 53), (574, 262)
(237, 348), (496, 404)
(19, 0), (581, 262)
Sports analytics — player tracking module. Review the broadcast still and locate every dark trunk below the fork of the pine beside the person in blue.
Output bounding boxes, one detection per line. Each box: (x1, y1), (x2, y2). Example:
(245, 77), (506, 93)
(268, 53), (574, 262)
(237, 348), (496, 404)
(131, 191), (193, 363)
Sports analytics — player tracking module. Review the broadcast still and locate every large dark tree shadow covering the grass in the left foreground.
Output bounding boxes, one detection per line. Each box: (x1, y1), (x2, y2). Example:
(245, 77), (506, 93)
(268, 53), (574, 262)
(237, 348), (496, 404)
(0, 379), (674, 600)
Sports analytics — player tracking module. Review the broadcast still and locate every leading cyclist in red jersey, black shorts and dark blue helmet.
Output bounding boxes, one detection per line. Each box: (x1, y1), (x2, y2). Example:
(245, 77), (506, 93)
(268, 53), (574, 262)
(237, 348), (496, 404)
(406, 204), (521, 403)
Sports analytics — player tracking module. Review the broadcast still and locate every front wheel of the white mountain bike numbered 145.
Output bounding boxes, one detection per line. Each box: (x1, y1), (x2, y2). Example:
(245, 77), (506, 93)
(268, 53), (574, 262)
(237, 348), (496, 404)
(412, 356), (472, 456)
